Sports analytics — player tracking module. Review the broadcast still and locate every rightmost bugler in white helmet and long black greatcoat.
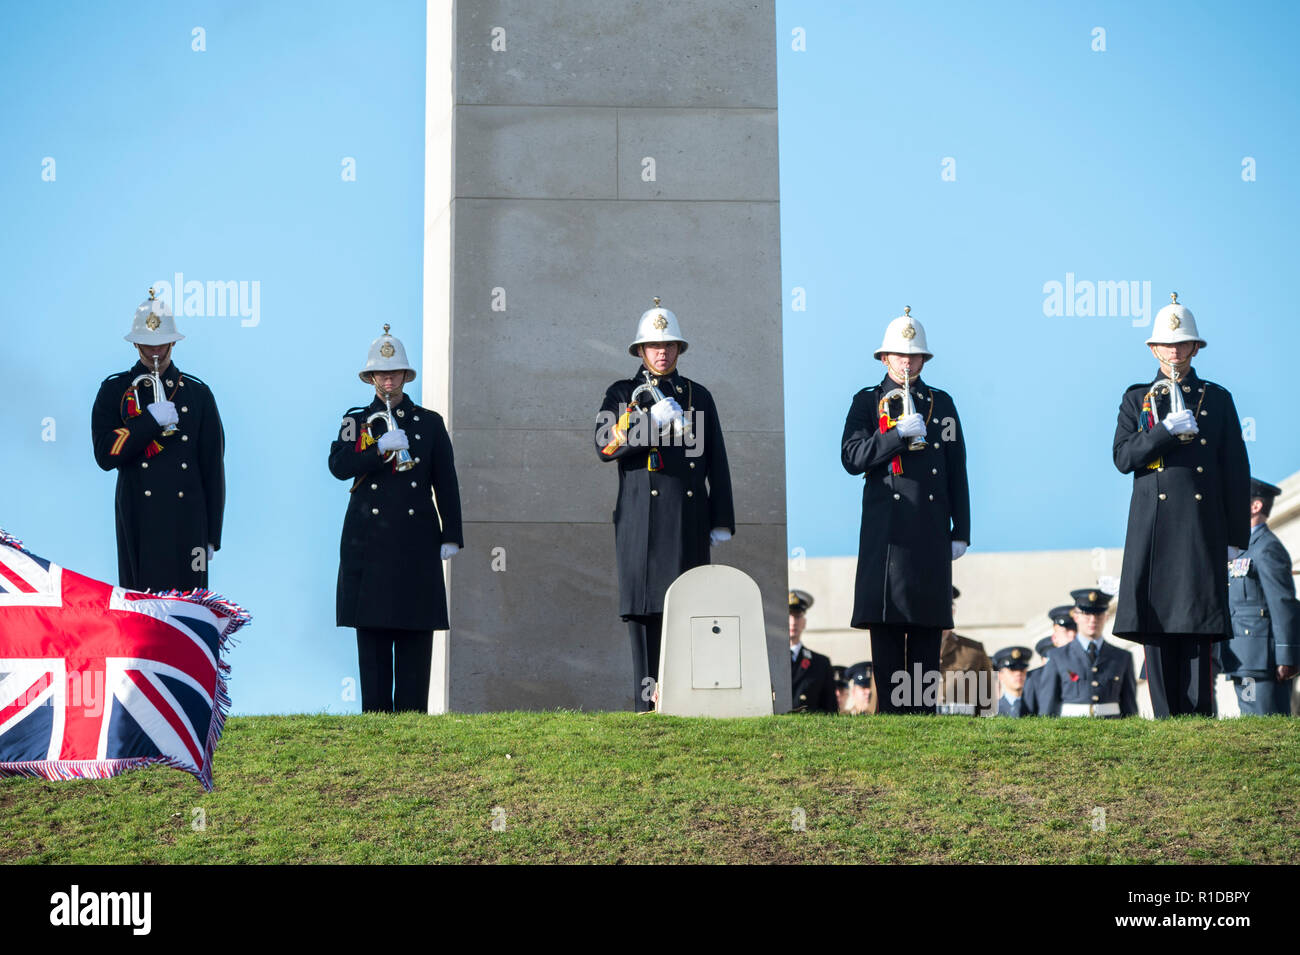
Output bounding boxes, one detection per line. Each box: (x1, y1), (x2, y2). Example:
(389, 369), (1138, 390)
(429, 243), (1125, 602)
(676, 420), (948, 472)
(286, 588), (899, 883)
(1114, 294), (1251, 717)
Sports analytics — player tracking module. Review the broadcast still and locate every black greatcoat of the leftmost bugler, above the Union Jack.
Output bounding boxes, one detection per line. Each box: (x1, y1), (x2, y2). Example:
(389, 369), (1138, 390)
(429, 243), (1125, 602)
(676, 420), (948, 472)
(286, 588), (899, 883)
(90, 361), (226, 591)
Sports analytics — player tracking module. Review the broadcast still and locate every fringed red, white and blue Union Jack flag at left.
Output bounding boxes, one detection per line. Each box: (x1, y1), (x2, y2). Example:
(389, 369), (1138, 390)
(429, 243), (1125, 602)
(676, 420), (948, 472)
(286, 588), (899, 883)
(0, 530), (251, 791)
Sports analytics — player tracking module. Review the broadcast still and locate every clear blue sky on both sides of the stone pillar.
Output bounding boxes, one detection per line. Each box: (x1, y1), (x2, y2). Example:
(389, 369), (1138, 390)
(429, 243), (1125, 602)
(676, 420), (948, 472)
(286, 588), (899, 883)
(0, 0), (1300, 712)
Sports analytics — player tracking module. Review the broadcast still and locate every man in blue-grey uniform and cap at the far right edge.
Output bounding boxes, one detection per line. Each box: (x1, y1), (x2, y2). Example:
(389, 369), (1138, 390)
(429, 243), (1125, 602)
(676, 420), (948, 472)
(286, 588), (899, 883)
(1216, 478), (1300, 716)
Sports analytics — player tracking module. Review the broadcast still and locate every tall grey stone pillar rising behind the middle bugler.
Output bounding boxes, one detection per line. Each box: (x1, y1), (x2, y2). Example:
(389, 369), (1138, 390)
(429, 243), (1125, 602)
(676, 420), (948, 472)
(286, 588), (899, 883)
(423, 0), (789, 712)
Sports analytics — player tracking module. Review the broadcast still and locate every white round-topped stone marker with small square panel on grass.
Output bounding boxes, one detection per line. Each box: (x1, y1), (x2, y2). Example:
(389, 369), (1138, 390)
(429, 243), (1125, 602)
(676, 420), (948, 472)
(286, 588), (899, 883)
(659, 564), (772, 716)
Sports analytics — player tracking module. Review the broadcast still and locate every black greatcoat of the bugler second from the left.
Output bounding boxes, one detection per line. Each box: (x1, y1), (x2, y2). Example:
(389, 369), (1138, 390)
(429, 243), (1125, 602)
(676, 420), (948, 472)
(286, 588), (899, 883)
(329, 395), (465, 630)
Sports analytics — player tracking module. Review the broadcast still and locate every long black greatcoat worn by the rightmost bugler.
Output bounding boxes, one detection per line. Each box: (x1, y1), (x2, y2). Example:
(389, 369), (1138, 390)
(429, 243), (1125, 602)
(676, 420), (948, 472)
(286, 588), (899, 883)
(1114, 369), (1251, 642)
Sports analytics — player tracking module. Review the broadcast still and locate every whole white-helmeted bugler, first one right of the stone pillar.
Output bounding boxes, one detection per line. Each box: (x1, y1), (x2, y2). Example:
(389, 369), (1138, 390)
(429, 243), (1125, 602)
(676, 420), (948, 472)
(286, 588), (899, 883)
(840, 308), (970, 713)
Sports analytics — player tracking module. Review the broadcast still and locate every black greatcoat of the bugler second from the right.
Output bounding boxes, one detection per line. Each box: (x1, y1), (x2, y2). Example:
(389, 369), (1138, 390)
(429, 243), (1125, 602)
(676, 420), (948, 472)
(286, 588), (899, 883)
(840, 376), (971, 629)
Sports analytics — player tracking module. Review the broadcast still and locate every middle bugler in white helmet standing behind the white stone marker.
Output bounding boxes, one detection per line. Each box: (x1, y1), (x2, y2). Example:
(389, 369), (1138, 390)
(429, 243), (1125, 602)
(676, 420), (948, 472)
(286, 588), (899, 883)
(595, 298), (736, 711)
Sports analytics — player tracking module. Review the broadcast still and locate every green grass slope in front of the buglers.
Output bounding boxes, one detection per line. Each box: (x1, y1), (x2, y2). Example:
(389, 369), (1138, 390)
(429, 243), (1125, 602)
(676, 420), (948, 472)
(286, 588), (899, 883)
(0, 712), (1300, 864)
